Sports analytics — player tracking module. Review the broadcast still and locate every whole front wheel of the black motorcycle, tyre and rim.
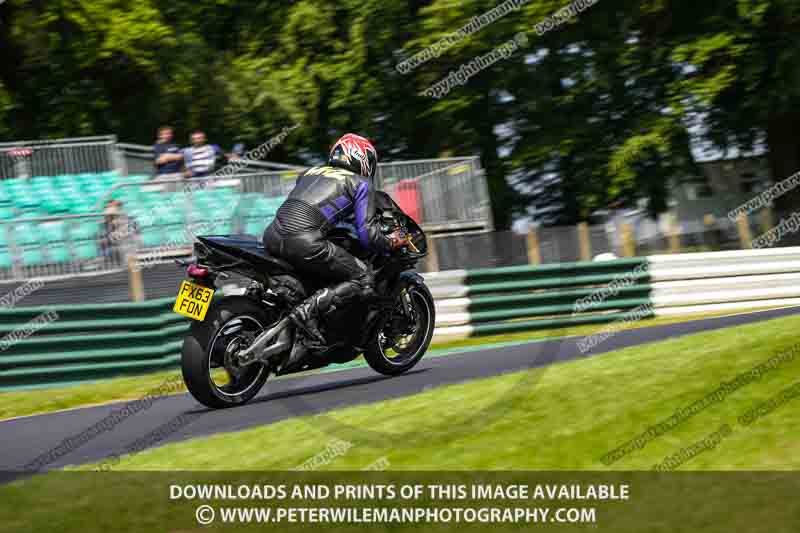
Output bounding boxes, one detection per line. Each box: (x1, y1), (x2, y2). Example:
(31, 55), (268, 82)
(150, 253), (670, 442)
(364, 283), (436, 376)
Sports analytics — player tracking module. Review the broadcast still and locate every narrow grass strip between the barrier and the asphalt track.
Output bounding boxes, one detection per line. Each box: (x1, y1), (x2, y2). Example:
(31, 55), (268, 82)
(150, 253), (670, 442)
(0, 313), (768, 420)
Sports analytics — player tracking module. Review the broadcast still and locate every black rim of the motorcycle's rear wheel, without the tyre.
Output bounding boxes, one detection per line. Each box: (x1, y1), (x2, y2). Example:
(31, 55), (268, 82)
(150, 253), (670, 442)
(208, 315), (266, 399)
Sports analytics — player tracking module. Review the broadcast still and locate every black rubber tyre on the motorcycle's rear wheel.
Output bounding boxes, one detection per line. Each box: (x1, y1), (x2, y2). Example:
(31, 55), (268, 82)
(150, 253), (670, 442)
(181, 296), (277, 409)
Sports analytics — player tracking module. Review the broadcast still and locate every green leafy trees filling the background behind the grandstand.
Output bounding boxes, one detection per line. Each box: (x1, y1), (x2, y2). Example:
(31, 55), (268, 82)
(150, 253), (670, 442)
(0, 0), (800, 227)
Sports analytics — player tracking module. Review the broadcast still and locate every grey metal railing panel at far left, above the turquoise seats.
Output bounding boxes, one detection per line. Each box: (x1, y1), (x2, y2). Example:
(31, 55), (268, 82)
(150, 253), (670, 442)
(0, 135), (125, 179)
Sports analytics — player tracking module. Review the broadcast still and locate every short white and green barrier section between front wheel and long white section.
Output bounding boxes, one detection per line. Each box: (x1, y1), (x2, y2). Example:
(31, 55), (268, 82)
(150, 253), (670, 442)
(425, 258), (652, 340)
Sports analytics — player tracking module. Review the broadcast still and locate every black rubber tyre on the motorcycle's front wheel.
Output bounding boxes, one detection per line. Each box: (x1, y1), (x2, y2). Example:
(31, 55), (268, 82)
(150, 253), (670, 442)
(364, 281), (436, 376)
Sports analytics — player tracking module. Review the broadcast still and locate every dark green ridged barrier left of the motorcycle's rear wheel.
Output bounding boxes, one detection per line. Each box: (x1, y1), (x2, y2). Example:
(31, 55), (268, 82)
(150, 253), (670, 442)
(0, 298), (188, 390)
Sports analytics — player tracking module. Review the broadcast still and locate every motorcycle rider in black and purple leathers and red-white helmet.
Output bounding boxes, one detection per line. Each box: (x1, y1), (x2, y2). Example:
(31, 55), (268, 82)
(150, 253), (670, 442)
(263, 133), (404, 365)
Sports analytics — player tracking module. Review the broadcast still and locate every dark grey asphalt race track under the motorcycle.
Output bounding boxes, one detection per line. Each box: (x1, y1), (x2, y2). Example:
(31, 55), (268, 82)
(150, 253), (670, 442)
(0, 307), (800, 482)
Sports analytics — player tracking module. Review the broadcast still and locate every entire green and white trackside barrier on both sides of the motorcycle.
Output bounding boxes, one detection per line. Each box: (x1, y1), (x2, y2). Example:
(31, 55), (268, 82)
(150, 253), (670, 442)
(0, 248), (800, 390)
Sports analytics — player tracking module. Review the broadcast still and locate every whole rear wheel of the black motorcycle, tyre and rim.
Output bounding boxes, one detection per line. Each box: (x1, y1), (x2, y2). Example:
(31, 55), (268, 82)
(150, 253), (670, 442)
(181, 296), (278, 409)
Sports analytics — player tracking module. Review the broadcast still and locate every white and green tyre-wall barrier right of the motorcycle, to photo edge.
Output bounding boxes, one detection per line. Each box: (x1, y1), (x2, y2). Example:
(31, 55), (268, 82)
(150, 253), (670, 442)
(432, 247), (800, 340)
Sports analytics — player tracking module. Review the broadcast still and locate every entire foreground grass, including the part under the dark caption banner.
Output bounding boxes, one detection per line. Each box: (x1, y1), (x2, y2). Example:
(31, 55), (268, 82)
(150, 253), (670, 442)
(0, 317), (800, 533)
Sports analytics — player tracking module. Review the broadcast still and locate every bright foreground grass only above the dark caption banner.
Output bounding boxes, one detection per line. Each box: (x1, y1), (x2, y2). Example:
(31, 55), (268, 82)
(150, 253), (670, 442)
(72, 310), (800, 470)
